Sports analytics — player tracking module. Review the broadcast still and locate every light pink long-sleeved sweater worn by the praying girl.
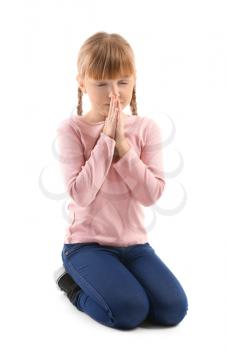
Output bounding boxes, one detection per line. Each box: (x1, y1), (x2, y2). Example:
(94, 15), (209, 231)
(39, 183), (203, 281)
(57, 115), (165, 247)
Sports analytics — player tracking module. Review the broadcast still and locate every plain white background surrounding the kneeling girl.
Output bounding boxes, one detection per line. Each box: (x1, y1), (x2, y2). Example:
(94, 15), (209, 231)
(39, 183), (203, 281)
(0, 0), (227, 350)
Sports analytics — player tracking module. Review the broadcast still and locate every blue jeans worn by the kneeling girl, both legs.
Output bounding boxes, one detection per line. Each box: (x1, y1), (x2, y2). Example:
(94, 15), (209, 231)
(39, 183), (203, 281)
(62, 242), (188, 329)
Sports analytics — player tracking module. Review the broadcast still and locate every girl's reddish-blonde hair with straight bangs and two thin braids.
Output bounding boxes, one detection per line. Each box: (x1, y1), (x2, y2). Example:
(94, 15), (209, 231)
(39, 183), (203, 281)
(77, 32), (137, 115)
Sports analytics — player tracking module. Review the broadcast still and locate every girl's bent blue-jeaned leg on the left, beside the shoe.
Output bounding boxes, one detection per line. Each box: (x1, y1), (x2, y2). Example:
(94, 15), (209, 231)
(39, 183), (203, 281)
(62, 243), (149, 329)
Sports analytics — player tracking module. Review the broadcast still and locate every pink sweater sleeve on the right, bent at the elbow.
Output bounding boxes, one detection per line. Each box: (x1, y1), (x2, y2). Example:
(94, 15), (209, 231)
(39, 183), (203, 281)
(113, 121), (165, 206)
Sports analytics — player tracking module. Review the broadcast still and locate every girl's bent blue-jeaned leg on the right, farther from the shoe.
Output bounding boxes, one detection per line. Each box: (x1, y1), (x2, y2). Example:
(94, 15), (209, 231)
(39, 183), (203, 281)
(125, 243), (188, 326)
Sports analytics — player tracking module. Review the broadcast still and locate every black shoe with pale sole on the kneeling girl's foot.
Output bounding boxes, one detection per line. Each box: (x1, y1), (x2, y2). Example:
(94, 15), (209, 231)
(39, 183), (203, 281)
(54, 266), (81, 303)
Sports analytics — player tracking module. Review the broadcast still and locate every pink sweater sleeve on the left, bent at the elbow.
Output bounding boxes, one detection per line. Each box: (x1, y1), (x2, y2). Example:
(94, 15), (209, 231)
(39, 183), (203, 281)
(57, 124), (115, 207)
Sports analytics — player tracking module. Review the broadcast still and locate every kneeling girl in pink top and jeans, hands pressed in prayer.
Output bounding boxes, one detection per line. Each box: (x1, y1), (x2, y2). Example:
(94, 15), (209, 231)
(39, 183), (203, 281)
(55, 32), (188, 329)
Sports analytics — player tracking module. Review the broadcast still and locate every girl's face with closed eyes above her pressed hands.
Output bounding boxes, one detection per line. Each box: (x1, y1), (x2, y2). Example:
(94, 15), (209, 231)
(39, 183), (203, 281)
(79, 75), (135, 116)
